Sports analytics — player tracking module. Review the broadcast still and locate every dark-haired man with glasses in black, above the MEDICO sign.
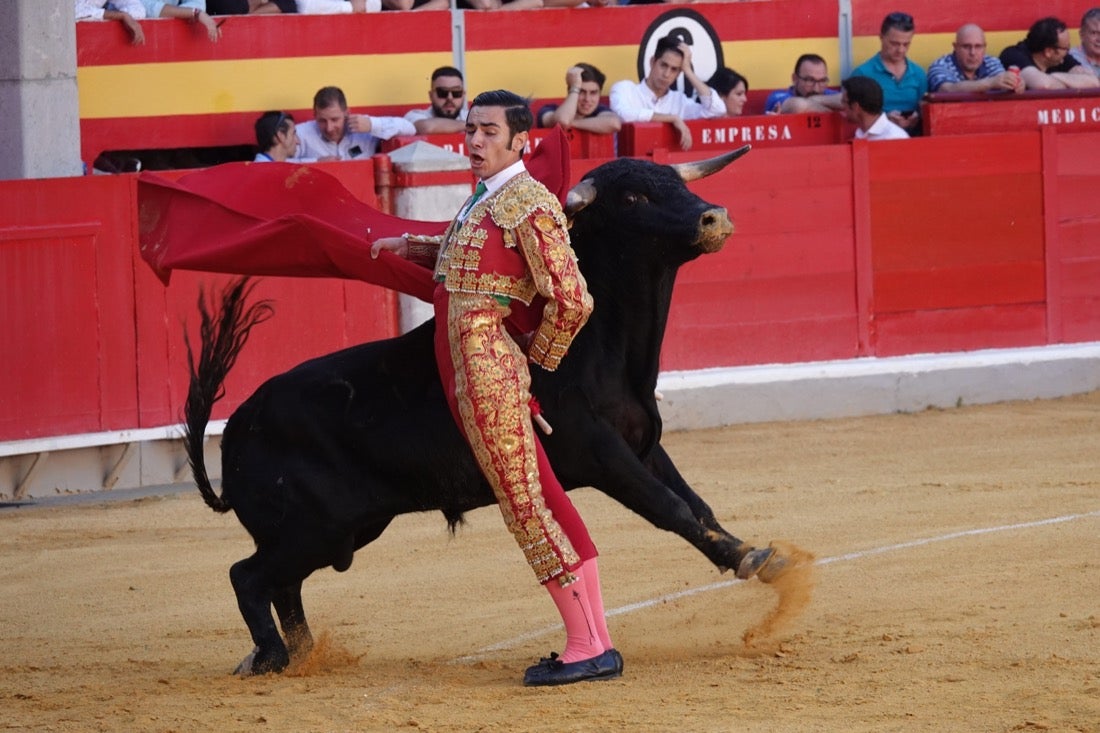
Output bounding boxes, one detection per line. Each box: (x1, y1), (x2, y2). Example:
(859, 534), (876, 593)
(1001, 18), (1100, 89)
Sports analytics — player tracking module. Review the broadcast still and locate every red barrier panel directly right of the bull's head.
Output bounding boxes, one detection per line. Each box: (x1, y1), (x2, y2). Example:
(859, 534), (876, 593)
(661, 145), (858, 370)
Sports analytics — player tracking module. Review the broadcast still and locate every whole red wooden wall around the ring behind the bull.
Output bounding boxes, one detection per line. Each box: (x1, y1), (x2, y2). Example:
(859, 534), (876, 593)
(0, 129), (1100, 440)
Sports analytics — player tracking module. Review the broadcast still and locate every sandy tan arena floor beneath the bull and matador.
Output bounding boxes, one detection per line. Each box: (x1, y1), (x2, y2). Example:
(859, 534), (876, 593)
(0, 393), (1100, 733)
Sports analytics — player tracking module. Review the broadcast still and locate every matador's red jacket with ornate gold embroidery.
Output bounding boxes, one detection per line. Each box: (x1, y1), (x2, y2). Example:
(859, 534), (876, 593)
(408, 172), (592, 371)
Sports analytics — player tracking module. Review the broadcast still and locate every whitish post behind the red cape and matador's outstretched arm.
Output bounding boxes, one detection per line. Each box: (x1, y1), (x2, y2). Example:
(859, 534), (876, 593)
(389, 141), (472, 332)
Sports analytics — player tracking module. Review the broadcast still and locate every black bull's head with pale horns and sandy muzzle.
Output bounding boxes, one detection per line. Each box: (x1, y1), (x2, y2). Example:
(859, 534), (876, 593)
(565, 145), (750, 260)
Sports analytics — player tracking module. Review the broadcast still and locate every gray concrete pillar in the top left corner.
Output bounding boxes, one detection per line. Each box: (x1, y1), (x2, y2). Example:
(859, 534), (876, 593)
(0, 0), (83, 179)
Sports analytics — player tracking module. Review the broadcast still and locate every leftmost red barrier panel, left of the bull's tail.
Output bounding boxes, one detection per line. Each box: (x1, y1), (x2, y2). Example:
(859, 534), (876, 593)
(0, 176), (139, 440)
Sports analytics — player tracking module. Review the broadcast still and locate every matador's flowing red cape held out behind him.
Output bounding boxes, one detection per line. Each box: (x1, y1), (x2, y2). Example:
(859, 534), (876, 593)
(138, 128), (570, 302)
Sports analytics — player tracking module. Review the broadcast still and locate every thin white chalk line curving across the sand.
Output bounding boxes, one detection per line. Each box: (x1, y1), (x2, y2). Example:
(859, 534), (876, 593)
(452, 510), (1100, 664)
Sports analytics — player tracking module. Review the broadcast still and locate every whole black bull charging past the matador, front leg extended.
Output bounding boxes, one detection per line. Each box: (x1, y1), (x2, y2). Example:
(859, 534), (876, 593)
(186, 149), (785, 674)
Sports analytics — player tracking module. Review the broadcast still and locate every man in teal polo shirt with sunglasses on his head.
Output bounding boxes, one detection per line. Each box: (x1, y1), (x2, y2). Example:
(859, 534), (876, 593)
(851, 13), (928, 134)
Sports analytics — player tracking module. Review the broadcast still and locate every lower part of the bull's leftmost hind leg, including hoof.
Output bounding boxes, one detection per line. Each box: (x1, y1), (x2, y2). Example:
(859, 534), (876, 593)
(229, 553), (290, 675)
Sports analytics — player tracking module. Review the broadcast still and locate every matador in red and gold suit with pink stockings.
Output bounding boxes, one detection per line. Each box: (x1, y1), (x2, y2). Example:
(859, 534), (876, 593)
(372, 90), (623, 686)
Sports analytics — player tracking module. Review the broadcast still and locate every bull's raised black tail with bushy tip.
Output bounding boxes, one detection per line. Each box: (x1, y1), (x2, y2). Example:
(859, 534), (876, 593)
(184, 277), (275, 512)
